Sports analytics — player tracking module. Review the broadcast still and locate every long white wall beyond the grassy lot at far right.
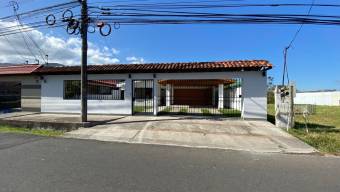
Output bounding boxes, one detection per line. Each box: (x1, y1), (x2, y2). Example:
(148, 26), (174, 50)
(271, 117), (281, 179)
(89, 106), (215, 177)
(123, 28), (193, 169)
(294, 91), (340, 106)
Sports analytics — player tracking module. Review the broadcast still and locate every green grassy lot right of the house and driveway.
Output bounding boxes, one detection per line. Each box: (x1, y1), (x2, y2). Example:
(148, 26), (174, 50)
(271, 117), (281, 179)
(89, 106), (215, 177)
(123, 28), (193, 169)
(268, 104), (340, 155)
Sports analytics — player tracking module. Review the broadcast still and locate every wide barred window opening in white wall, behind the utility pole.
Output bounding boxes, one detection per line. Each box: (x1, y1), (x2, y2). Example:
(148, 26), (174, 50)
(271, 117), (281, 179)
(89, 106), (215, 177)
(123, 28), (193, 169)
(64, 80), (125, 100)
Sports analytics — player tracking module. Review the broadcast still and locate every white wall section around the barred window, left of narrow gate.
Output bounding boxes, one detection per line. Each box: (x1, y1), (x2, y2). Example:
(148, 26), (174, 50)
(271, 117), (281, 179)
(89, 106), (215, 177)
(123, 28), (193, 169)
(41, 74), (132, 115)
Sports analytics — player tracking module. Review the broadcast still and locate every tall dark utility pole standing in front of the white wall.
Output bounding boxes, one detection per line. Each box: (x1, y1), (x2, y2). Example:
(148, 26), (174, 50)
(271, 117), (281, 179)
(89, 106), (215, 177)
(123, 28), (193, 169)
(80, 0), (88, 123)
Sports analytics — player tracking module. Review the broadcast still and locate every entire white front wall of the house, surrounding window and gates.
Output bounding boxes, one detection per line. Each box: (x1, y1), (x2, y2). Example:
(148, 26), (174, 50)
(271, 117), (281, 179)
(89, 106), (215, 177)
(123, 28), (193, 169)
(41, 71), (267, 119)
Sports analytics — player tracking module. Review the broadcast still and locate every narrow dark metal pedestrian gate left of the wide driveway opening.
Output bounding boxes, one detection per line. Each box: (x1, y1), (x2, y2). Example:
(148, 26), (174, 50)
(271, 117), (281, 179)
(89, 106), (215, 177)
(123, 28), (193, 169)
(132, 80), (154, 115)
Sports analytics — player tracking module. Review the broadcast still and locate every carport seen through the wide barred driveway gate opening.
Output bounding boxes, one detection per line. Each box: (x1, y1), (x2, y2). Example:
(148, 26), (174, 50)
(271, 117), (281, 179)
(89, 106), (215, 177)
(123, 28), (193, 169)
(158, 79), (242, 117)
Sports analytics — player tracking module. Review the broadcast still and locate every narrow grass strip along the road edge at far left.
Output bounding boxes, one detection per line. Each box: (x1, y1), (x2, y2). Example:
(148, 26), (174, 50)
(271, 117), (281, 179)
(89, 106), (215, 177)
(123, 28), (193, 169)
(0, 125), (64, 137)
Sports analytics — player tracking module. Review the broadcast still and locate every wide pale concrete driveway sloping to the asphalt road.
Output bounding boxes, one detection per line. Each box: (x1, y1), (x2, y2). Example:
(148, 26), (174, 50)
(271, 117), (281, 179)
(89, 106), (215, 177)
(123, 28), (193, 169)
(65, 116), (316, 153)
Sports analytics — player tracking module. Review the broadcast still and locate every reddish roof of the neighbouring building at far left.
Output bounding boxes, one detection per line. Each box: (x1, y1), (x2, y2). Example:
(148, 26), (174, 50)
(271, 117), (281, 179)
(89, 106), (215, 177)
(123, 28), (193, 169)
(0, 64), (41, 75)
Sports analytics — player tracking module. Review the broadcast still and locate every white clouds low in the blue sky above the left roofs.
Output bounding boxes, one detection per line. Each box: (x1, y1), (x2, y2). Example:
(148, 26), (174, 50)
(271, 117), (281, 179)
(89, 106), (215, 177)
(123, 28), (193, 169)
(0, 21), (119, 65)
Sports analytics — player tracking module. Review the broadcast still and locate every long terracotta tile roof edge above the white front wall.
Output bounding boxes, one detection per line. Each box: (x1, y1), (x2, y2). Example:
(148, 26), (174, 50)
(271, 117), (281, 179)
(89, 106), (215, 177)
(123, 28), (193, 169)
(34, 60), (272, 75)
